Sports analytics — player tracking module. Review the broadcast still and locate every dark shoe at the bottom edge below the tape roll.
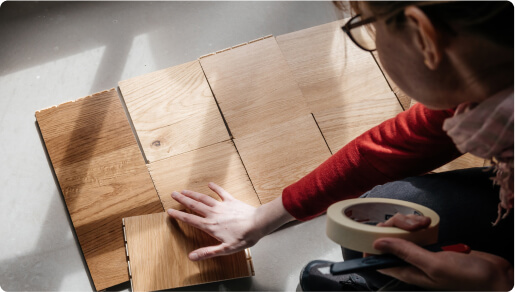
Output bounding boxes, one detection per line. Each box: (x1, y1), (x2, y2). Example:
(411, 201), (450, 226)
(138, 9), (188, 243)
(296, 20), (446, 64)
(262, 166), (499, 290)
(300, 260), (372, 291)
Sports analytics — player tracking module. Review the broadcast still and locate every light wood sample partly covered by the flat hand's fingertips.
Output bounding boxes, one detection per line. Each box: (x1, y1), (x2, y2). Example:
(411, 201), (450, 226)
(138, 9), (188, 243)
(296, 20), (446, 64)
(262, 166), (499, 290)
(148, 141), (260, 210)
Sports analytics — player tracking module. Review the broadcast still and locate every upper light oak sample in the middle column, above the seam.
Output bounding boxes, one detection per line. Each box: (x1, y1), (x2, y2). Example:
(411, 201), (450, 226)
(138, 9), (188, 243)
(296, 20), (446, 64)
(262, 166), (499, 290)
(200, 37), (310, 138)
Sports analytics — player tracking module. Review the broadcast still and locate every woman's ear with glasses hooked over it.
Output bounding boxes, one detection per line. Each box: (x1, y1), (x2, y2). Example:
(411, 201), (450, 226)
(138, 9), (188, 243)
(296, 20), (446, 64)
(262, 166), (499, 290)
(404, 6), (443, 70)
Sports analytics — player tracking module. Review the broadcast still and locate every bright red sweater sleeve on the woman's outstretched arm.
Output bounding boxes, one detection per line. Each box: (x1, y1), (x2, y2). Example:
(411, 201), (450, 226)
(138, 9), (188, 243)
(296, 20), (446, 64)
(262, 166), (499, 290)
(282, 104), (461, 220)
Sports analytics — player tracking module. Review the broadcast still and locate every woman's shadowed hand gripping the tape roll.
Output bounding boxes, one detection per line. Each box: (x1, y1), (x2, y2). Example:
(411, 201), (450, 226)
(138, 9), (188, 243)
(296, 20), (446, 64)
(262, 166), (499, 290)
(374, 215), (513, 291)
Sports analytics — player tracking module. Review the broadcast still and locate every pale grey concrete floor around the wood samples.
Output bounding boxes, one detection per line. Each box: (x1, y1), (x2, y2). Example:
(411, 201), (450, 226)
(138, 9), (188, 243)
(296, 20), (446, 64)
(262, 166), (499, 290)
(0, 2), (348, 291)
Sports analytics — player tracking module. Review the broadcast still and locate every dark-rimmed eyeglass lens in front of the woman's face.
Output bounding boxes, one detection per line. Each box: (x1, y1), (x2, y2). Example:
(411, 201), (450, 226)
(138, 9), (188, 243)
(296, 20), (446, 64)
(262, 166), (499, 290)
(342, 14), (376, 52)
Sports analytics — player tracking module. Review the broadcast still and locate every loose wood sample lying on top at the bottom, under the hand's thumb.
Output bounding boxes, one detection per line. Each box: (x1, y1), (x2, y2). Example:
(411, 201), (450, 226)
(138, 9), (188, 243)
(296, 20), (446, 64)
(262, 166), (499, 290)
(124, 213), (253, 291)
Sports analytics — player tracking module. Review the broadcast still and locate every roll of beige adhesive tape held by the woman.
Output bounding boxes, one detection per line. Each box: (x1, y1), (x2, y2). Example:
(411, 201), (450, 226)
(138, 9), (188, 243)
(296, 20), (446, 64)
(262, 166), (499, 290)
(326, 198), (440, 254)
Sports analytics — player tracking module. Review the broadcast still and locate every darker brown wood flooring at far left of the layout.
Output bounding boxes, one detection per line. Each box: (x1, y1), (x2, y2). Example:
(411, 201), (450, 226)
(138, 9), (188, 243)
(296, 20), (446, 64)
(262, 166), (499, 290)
(36, 89), (163, 290)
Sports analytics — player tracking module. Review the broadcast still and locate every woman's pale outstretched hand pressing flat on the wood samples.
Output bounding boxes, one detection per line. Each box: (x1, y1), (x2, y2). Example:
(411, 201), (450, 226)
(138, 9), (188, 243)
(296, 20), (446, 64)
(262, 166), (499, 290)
(168, 183), (293, 261)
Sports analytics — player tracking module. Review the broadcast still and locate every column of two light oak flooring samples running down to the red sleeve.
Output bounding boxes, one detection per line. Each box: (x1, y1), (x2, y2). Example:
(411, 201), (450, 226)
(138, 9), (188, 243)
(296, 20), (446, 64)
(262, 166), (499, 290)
(200, 37), (330, 204)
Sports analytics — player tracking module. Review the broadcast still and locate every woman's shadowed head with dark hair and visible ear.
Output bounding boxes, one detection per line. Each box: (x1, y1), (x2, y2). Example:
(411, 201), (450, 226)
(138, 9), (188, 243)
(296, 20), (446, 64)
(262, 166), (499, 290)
(340, 1), (513, 108)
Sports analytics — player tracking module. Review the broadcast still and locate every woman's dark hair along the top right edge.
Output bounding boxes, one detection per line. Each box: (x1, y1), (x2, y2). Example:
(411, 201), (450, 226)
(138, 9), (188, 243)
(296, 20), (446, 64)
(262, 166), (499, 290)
(337, 1), (514, 48)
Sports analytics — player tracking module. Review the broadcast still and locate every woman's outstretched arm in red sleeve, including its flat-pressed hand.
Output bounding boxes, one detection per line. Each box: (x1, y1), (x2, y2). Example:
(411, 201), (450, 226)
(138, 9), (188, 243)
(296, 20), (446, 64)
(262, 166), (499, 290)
(168, 104), (460, 260)
